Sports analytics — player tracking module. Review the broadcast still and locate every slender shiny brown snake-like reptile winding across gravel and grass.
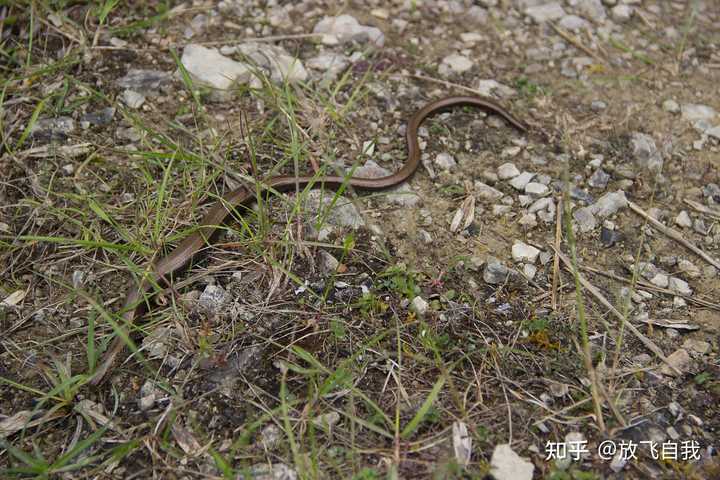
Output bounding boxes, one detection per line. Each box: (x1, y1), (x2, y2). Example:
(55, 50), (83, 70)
(90, 96), (527, 385)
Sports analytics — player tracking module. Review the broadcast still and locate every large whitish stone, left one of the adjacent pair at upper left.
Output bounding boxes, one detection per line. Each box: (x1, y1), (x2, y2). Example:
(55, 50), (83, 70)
(181, 44), (252, 90)
